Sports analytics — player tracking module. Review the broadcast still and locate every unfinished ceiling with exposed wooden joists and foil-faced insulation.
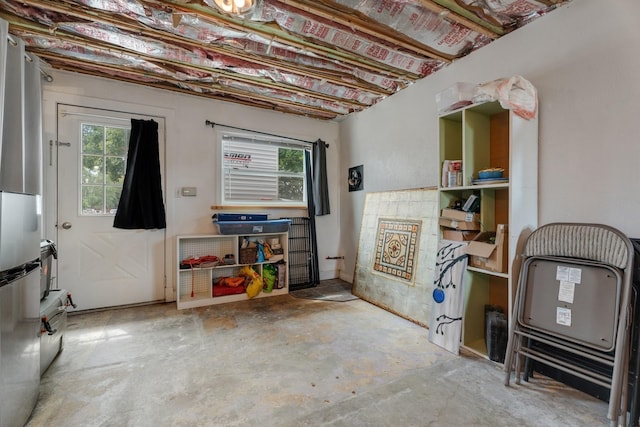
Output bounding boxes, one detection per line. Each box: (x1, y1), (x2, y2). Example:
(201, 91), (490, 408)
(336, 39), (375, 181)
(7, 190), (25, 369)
(0, 0), (568, 119)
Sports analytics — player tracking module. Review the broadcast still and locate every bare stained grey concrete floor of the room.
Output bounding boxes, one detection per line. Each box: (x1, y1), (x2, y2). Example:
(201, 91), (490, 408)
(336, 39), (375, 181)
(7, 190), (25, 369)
(27, 285), (608, 427)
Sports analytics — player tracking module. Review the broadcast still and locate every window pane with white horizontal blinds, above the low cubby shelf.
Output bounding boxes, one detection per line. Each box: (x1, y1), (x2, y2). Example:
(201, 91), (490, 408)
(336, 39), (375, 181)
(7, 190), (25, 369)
(221, 134), (307, 207)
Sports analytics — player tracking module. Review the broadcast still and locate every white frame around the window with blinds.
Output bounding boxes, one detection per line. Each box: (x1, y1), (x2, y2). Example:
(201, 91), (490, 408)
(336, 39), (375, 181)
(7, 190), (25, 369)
(216, 131), (312, 209)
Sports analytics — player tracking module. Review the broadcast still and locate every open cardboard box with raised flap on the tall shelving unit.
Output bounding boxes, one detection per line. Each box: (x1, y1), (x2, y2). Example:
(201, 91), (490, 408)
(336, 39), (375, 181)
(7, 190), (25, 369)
(465, 224), (509, 273)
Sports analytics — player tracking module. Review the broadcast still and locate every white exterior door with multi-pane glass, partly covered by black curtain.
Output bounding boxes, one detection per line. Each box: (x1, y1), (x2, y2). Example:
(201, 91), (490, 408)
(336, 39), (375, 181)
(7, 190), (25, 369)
(55, 104), (166, 310)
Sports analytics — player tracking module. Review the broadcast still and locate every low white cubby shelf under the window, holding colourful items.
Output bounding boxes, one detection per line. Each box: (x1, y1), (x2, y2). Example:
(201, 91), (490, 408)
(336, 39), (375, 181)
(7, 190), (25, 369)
(176, 232), (289, 309)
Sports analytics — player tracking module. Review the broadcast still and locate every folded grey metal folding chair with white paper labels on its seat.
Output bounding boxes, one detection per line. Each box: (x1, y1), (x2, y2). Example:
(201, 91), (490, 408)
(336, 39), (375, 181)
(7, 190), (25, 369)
(504, 223), (634, 426)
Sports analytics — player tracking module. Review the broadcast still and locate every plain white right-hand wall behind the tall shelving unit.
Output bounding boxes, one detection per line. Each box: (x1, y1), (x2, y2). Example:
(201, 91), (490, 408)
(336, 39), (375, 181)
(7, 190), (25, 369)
(340, 0), (640, 281)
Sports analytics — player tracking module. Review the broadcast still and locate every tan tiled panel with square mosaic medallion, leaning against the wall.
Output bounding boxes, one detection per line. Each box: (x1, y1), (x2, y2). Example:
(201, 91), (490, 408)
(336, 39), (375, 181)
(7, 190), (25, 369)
(352, 188), (438, 326)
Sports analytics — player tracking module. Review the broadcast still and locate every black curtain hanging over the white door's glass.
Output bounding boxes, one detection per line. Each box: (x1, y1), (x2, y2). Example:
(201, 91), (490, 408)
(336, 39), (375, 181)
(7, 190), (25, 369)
(113, 119), (167, 230)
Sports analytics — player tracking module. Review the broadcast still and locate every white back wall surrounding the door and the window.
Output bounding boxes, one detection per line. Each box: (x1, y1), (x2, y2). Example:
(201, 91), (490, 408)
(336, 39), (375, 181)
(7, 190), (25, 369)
(43, 70), (340, 300)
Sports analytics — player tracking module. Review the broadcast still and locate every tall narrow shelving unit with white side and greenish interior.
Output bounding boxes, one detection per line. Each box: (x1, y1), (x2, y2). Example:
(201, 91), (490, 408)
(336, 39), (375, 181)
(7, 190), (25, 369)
(438, 102), (538, 357)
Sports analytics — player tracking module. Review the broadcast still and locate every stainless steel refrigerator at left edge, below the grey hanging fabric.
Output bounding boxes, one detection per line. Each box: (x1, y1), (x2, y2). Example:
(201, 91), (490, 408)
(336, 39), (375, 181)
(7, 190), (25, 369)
(0, 191), (40, 426)
